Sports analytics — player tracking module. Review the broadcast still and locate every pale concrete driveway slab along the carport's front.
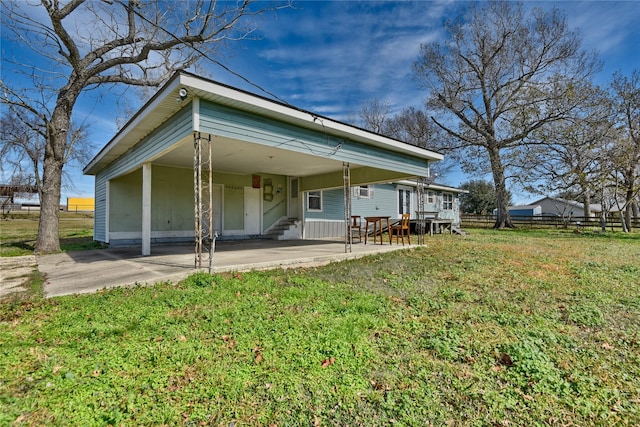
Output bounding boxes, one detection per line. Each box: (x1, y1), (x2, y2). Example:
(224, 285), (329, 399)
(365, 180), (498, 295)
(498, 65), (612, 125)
(37, 240), (410, 297)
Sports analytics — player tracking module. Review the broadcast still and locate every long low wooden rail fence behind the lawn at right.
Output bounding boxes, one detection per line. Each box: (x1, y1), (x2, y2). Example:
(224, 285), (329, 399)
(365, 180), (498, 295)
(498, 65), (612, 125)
(461, 214), (640, 231)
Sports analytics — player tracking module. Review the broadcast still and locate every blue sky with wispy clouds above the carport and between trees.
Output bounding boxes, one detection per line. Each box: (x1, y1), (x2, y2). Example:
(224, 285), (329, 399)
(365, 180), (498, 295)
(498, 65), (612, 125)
(3, 1), (640, 203)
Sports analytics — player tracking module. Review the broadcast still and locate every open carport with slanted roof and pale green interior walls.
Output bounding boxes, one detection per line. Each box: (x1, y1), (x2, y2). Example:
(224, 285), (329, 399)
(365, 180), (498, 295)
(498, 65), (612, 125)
(84, 72), (443, 255)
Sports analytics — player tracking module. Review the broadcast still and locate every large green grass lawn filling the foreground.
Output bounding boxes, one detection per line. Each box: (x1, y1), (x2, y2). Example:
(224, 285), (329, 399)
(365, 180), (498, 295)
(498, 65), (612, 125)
(0, 230), (640, 426)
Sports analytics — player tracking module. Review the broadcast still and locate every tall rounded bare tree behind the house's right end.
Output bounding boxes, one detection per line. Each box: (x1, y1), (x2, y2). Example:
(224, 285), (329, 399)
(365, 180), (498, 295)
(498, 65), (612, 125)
(414, 1), (599, 228)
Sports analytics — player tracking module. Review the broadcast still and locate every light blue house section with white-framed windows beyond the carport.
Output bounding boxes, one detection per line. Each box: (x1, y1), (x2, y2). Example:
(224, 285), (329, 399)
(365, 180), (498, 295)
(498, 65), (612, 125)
(304, 180), (466, 238)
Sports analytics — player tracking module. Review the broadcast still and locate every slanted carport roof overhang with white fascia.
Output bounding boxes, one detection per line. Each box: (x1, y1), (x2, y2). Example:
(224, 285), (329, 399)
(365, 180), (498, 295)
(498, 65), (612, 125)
(84, 71), (443, 175)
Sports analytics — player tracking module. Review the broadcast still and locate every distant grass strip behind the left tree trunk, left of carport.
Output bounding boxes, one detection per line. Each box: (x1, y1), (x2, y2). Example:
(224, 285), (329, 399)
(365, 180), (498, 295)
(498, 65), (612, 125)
(0, 213), (100, 256)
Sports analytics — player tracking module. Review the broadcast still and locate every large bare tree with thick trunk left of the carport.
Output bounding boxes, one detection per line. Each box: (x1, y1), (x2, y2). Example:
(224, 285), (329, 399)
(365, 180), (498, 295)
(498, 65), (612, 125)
(0, 0), (284, 253)
